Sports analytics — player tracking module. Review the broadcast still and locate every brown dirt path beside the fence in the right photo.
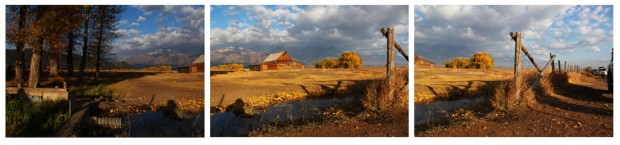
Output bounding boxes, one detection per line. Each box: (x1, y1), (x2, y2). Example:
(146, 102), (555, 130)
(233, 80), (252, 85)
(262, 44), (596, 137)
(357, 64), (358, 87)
(416, 77), (613, 137)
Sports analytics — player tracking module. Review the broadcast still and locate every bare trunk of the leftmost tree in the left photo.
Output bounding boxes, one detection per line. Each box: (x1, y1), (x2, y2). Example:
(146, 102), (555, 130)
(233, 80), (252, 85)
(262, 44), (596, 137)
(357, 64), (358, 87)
(13, 6), (27, 84)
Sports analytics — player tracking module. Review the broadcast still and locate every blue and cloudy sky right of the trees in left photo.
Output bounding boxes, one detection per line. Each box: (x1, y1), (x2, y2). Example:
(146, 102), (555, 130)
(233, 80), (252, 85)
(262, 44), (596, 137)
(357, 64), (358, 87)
(112, 5), (205, 58)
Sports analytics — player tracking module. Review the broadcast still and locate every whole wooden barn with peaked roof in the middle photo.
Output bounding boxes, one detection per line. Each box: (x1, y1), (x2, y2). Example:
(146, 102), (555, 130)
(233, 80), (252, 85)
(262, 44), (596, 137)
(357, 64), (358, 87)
(250, 51), (305, 71)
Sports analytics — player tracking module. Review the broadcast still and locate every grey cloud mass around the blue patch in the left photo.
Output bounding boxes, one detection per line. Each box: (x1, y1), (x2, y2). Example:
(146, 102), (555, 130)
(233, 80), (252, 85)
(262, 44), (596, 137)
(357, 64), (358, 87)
(115, 6), (205, 56)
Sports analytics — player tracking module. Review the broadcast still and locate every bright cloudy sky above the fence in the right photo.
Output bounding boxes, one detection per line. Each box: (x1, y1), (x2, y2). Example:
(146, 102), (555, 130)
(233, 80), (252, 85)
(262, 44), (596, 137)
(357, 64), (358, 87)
(414, 5), (613, 68)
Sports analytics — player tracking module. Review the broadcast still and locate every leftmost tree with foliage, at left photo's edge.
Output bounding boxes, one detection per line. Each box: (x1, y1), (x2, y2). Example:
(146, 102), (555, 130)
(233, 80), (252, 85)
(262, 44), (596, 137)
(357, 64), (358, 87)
(6, 5), (29, 84)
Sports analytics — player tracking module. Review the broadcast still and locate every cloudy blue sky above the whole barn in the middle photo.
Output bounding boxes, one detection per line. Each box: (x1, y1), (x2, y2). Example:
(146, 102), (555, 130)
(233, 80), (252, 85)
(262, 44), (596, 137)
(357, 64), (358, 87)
(210, 5), (409, 65)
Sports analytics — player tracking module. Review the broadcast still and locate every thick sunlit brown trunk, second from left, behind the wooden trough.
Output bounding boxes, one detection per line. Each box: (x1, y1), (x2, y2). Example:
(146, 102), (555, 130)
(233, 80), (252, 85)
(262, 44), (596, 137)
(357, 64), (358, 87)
(28, 36), (43, 87)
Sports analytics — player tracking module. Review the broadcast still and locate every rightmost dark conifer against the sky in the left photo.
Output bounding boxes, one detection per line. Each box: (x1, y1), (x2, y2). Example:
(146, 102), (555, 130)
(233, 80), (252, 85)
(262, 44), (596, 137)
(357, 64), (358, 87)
(92, 5), (124, 80)
